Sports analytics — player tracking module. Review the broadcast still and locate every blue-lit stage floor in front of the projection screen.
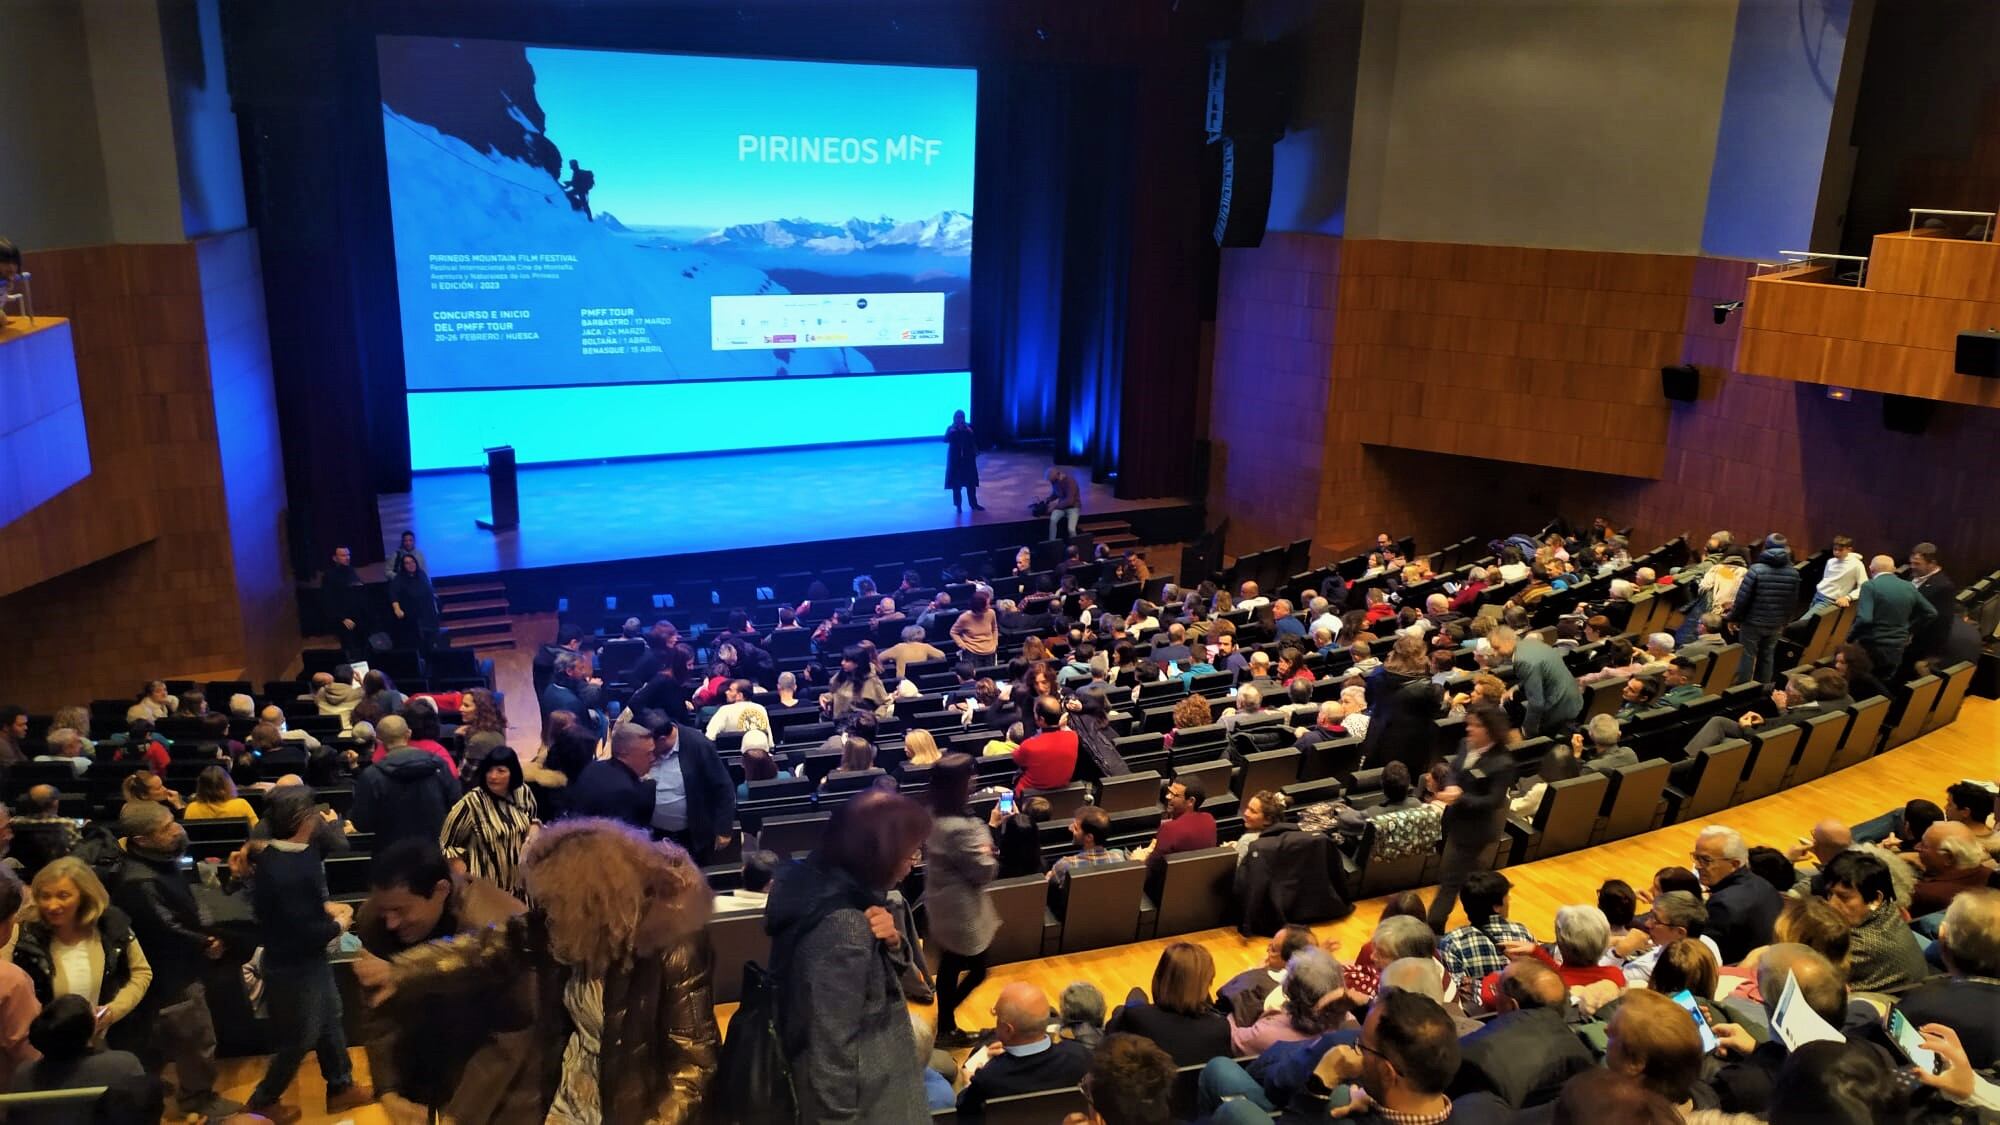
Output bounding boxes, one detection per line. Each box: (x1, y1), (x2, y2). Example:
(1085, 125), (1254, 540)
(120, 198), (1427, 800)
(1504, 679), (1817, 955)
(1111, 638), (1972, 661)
(376, 440), (1184, 579)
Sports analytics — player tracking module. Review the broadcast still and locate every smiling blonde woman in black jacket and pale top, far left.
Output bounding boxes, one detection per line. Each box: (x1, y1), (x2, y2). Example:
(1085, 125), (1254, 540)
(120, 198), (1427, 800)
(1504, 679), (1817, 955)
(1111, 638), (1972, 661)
(14, 855), (152, 1039)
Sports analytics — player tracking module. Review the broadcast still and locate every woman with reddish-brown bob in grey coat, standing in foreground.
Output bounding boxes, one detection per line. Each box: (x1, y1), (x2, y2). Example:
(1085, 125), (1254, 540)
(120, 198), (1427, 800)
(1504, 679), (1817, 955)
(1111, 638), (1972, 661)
(764, 791), (932, 1125)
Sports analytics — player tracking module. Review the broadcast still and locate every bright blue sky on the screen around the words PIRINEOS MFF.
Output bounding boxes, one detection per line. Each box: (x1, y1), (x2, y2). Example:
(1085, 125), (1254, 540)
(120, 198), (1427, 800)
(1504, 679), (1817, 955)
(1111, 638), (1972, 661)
(528, 48), (976, 228)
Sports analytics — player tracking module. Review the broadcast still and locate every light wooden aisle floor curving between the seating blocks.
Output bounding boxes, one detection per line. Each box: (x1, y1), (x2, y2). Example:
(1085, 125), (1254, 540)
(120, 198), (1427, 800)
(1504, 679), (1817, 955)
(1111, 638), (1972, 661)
(211, 696), (2000, 1125)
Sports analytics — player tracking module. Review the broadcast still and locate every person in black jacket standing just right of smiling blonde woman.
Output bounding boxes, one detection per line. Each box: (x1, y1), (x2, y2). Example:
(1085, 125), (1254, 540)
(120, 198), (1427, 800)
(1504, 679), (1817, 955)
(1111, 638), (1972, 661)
(116, 800), (242, 1117)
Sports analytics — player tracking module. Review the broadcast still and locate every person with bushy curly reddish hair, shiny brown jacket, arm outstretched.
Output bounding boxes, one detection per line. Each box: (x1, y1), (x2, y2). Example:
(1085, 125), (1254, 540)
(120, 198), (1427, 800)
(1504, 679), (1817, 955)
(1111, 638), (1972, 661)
(356, 819), (720, 1125)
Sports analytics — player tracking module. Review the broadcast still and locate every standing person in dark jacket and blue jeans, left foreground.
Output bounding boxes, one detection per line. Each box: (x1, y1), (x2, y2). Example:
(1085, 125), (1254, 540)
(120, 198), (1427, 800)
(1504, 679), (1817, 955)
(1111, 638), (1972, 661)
(244, 785), (374, 1125)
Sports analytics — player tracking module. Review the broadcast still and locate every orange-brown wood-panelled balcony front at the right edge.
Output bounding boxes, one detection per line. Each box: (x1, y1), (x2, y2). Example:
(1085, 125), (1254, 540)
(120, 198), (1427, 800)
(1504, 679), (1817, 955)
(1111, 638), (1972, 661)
(1736, 232), (2000, 406)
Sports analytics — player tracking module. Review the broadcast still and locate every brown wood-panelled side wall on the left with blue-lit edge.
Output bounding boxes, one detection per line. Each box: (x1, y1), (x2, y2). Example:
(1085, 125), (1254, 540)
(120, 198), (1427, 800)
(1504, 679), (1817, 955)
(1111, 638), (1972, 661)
(0, 236), (298, 709)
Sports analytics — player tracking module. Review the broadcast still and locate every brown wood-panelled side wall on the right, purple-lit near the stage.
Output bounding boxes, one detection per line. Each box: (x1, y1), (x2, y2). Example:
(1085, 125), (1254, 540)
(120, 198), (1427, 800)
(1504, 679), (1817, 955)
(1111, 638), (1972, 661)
(1210, 234), (2000, 575)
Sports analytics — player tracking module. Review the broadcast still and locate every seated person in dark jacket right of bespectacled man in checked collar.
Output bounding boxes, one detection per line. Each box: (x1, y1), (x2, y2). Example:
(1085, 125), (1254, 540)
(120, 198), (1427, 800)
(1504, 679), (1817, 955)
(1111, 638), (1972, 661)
(1452, 959), (1592, 1109)
